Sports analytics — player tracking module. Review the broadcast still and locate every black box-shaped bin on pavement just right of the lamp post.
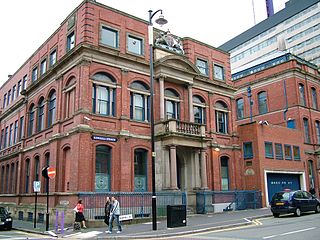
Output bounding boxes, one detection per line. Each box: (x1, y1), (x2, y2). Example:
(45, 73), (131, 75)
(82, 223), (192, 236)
(167, 205), (187, 228)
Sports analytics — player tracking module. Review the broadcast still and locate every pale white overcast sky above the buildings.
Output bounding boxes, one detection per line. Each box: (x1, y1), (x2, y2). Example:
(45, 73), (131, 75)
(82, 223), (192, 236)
(0, 0), (288, 86)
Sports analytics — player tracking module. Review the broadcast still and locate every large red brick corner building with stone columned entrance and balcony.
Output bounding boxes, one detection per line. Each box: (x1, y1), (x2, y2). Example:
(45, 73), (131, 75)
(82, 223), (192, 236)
(0, 0), (243, 218)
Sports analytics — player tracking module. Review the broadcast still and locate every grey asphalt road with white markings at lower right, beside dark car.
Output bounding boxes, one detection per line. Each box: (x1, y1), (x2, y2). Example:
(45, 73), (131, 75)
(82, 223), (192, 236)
(166, 213), (320, 240)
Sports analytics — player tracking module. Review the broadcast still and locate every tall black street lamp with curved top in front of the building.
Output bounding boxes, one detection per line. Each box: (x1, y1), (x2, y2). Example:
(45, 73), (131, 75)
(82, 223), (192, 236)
(148, 9), (168, 230)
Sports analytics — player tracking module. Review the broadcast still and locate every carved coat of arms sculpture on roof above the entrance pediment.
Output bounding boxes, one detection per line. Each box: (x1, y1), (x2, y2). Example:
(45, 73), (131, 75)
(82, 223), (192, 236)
(155, 30), (184, 54)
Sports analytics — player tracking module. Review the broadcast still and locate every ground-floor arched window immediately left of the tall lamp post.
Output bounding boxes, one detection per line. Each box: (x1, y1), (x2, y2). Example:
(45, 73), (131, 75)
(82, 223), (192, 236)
(134, 149), (148, 192)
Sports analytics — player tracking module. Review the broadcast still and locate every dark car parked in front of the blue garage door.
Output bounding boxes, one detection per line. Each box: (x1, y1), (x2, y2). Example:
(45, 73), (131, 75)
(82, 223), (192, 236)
(270, 190), (320, 217)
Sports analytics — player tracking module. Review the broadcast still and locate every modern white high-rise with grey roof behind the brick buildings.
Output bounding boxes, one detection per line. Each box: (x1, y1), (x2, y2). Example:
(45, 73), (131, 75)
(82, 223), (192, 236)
(219, 0), (320, 73)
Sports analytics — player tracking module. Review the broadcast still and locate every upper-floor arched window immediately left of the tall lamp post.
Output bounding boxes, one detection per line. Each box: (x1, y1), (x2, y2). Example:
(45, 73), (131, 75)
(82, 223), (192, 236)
(130, 81), (150, 121)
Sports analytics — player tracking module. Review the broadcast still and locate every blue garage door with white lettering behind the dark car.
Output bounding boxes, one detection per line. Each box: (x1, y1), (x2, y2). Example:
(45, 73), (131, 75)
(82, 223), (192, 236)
(267, 173), (300, 202)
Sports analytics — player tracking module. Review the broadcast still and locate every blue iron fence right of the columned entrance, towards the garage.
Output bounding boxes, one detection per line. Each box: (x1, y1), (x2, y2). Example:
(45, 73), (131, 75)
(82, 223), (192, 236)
(196, 191), (262, 214)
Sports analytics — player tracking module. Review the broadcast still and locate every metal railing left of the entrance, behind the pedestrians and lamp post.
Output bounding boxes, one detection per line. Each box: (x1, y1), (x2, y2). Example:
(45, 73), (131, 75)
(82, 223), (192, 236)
(78, 192), (186, 220)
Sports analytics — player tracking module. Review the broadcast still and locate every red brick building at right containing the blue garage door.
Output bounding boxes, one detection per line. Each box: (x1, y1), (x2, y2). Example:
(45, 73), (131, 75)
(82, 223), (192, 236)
(233, 54), (320, 205)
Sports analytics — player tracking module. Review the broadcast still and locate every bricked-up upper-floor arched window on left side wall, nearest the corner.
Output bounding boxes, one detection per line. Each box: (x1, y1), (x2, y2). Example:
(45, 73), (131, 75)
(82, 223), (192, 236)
(64, 77), (76, 118)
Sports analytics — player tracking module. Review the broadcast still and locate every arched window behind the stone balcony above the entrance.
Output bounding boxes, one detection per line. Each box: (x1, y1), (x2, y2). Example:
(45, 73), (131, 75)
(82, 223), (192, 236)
(164, 89), (180, 119)
